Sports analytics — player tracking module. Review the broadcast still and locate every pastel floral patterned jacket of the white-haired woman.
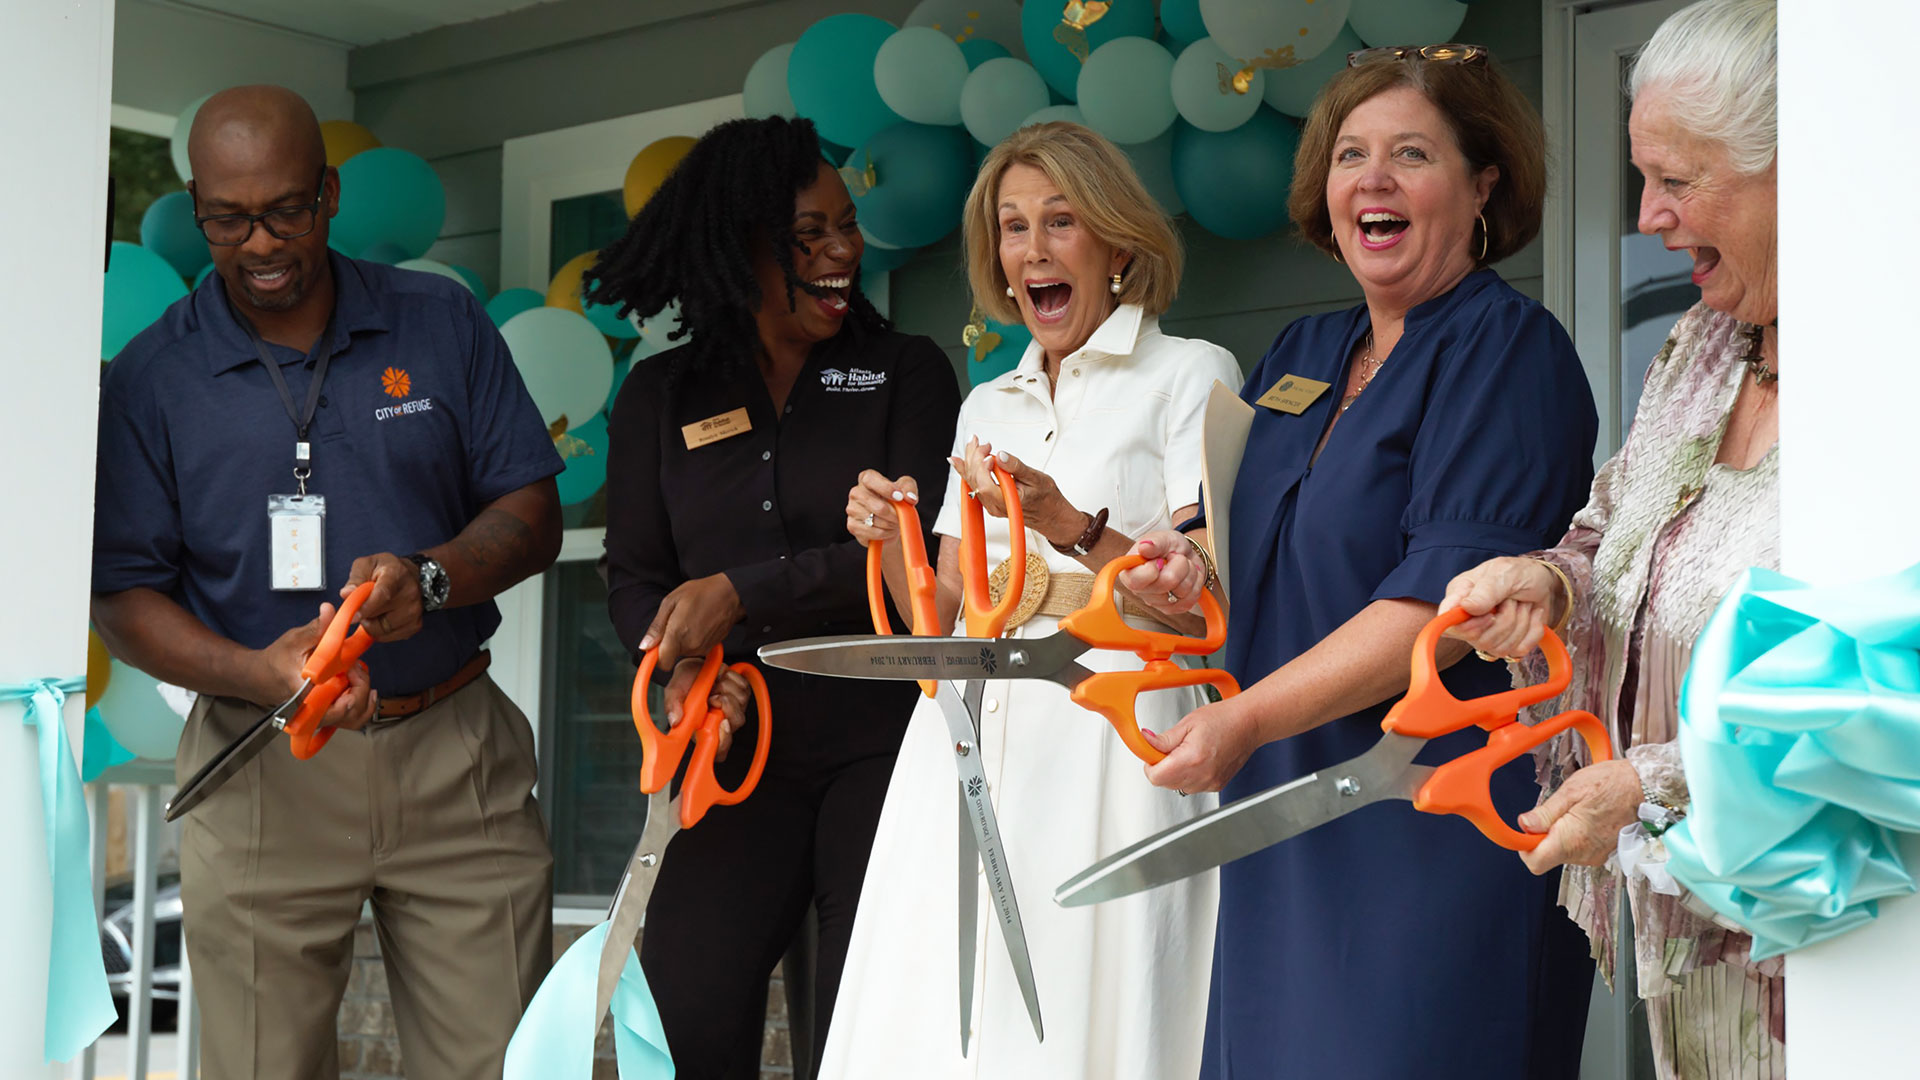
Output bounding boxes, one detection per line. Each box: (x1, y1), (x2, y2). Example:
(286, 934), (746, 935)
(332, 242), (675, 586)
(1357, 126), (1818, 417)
(1519, 304), (1782, 997)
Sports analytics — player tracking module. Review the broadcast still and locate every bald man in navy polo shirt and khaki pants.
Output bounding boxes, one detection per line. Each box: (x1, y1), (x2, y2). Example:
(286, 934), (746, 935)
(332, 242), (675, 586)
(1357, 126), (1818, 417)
(92, 86), (561, 1080)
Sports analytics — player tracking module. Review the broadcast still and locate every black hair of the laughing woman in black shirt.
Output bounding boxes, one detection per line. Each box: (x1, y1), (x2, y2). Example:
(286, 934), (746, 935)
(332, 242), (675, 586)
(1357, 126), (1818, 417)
(586, 117), (891, 369)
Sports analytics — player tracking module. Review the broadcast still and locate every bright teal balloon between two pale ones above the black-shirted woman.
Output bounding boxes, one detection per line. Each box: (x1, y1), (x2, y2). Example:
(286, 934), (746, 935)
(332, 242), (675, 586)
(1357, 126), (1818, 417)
(787, 15), (900, 146)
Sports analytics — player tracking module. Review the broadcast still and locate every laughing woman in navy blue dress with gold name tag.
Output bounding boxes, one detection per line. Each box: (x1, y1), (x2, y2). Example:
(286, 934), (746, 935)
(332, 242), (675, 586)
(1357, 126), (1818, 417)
(1125, 46), (1596, 1080)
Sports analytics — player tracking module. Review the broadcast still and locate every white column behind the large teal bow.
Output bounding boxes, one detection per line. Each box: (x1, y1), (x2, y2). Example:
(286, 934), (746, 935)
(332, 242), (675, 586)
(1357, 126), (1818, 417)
(1780, 0), (1920, 1080)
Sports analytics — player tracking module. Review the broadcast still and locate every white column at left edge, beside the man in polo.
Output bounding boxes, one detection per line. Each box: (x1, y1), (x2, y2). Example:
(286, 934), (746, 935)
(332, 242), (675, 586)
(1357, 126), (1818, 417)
(0, 0), (113, 1080)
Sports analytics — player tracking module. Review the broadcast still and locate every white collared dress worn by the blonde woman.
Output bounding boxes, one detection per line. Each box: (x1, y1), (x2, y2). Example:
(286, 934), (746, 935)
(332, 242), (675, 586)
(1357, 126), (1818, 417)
(820, 306), (1242, 1080)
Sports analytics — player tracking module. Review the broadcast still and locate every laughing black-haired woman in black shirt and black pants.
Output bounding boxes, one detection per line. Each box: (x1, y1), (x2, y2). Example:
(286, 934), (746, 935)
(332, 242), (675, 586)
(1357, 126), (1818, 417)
(588, 117), (960, 1080)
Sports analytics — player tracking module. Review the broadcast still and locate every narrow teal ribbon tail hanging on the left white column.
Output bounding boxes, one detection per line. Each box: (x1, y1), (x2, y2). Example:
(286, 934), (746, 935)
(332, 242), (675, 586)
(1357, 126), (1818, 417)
(0, 678), (113, 1063)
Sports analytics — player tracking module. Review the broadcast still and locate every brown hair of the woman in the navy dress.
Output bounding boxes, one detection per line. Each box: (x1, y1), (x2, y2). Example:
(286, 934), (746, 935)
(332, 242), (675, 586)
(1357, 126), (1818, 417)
(1286, 58), (1548, 265)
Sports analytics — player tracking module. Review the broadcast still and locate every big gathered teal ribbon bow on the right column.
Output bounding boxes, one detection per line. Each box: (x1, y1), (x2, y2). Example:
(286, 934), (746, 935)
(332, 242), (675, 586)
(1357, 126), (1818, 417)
(1665, 565), (1920, 959)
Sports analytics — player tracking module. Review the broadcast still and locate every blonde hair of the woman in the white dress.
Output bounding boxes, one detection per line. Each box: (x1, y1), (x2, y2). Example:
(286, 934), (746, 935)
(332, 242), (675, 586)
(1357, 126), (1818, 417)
(962, 121), (1183, 323)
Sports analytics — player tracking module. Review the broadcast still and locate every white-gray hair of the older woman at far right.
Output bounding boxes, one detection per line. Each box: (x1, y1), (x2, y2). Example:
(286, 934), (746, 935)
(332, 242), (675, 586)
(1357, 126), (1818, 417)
(1628, 0), (1780, 175)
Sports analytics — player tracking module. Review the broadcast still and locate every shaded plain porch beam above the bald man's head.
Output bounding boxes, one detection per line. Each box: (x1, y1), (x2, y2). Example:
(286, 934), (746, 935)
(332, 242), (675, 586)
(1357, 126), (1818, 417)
(112, 0), (353, 121)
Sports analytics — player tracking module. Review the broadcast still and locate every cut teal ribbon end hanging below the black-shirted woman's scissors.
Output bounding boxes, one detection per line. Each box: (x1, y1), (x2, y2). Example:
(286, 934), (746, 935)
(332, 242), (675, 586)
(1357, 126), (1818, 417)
(503, 922), (674, 1080)
